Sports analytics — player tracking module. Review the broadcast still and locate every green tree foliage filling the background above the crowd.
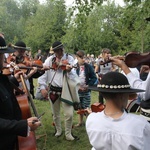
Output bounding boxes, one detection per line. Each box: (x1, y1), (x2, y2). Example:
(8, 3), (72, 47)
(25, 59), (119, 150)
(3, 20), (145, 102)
(0, 0), (150, 55)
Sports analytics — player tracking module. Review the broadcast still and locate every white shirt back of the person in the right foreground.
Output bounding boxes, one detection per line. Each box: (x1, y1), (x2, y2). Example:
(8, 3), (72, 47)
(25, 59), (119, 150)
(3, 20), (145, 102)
(86, 111), (150, 150)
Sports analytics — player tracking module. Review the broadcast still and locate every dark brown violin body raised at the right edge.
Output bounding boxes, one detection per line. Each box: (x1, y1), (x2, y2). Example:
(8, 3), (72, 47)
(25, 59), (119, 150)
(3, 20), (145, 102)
(124, 52), (150, 68)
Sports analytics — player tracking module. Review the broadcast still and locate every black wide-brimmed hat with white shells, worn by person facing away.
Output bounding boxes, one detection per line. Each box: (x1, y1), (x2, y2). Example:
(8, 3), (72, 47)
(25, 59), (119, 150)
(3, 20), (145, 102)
(89, 72), (144, 93)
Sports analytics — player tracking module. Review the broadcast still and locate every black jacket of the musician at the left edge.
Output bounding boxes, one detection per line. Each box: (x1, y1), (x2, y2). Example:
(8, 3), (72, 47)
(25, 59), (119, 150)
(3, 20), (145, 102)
(0, 74), (28, 150)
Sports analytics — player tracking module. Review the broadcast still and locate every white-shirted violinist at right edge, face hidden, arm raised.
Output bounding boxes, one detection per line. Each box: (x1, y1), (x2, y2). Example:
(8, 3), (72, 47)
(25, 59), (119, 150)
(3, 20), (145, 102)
(110, 57), (150, 122)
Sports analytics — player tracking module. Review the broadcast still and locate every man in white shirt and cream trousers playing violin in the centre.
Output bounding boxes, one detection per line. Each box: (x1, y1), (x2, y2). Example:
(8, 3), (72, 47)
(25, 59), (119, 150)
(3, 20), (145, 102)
(38, 41), (77, 141)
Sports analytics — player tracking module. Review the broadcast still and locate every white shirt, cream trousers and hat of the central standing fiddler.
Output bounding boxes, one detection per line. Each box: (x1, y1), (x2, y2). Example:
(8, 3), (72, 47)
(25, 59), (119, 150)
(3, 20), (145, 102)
(38, 41), (78, 140)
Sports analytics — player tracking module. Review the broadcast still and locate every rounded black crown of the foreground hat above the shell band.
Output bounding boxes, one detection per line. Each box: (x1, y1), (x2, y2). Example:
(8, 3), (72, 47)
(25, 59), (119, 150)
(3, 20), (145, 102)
(100, 72), (129, 86)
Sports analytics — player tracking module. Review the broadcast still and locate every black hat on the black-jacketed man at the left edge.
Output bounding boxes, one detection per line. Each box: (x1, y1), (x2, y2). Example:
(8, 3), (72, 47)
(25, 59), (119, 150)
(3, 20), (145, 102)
(0, 36), (15, 53)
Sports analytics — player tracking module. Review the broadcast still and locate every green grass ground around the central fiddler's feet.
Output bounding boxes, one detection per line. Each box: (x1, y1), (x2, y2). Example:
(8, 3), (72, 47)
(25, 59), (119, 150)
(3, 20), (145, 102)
(34, 87), (98, 150)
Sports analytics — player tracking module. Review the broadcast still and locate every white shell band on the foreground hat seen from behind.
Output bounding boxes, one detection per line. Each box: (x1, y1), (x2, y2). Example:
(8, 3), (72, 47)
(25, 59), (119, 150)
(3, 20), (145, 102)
(97, 84), (131, 89)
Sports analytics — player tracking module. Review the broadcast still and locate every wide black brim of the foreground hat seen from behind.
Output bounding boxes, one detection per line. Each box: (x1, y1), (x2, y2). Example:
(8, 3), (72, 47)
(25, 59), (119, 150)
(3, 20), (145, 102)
(88, 86), (145, 93)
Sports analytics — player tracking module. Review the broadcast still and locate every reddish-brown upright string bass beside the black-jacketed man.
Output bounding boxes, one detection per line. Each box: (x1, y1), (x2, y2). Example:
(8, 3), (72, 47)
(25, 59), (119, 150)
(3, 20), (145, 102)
(11, 66), (38, 150)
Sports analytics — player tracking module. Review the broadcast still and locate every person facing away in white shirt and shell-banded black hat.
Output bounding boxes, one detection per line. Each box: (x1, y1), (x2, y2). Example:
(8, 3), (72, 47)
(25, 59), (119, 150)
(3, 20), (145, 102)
(86, 72), (150, 150)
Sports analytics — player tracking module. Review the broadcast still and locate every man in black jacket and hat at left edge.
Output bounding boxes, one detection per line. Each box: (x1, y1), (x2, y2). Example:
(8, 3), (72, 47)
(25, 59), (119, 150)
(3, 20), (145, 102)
(0, 37), (41, 150)
